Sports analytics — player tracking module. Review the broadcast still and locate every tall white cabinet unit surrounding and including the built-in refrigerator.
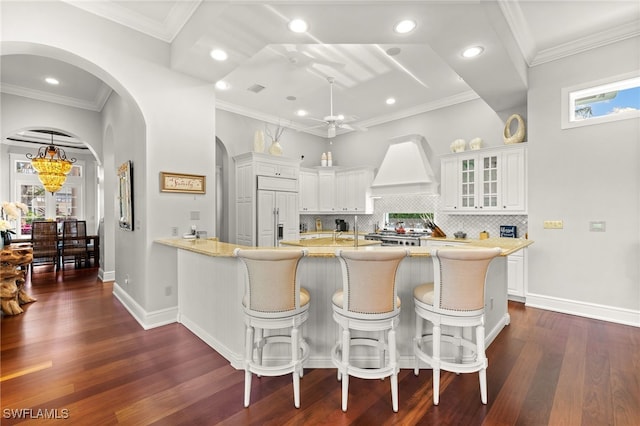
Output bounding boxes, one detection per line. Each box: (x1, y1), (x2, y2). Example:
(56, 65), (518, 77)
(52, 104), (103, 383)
(234, 152), (300, 246)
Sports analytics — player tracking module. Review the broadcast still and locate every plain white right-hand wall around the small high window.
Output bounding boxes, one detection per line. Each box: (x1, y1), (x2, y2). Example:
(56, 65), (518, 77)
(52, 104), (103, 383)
(528, 37), (640, 325)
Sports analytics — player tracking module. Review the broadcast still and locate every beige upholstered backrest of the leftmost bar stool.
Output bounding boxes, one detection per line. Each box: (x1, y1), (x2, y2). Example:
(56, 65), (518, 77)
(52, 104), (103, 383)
(233, 249), (307, 313)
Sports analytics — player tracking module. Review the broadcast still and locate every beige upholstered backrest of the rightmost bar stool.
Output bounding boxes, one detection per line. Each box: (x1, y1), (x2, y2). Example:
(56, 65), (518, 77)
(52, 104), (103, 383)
(431, 247), (501, 315)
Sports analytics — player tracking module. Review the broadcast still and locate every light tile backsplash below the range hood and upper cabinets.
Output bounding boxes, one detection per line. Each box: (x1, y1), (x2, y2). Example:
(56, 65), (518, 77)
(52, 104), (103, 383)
(300, 194), (528, 238)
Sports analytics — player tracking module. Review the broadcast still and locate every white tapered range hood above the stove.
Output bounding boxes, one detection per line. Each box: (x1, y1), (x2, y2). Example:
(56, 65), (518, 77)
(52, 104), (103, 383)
(371, 135), (438, 196)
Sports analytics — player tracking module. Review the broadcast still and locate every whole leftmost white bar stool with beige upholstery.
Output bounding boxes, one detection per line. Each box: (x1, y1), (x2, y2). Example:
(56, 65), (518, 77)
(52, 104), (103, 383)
(234, 249), (311, 408)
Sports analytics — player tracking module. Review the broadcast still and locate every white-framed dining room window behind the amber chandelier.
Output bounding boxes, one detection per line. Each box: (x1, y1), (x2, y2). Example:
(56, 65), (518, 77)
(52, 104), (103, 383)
(11, 154), (85, 235)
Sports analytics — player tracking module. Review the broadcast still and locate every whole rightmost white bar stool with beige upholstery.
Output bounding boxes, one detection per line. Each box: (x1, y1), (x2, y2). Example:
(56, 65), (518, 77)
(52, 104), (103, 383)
(413, 248), (500, 405)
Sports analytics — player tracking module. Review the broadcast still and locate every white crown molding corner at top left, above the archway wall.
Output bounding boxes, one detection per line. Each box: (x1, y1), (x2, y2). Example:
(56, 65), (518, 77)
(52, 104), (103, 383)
(62, 0), (202, 43)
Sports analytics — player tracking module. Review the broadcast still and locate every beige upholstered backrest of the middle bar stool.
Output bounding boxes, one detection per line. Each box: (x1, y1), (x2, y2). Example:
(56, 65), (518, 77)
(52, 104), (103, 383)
(336, 250), (408, 315)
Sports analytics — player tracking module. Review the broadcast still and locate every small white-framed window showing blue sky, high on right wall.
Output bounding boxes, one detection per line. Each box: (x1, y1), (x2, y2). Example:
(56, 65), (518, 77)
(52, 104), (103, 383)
(562, 73), (640, 129)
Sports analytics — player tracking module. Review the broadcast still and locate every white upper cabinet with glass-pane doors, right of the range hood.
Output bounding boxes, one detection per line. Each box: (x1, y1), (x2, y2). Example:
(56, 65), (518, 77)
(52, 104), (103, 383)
(440, 144), (527, 214)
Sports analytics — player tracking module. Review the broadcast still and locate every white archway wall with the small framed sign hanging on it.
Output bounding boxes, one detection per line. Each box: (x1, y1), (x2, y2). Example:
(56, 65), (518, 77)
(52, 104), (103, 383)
(1, 1), (215, 324)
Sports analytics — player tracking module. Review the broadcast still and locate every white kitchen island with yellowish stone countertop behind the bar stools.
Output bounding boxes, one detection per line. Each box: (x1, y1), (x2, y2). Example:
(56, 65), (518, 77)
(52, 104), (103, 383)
(156, 239), (530, 369)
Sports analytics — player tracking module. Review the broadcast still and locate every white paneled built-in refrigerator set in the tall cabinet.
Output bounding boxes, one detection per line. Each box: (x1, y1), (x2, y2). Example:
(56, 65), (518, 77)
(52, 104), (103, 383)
(257, 176), (300, 247)
